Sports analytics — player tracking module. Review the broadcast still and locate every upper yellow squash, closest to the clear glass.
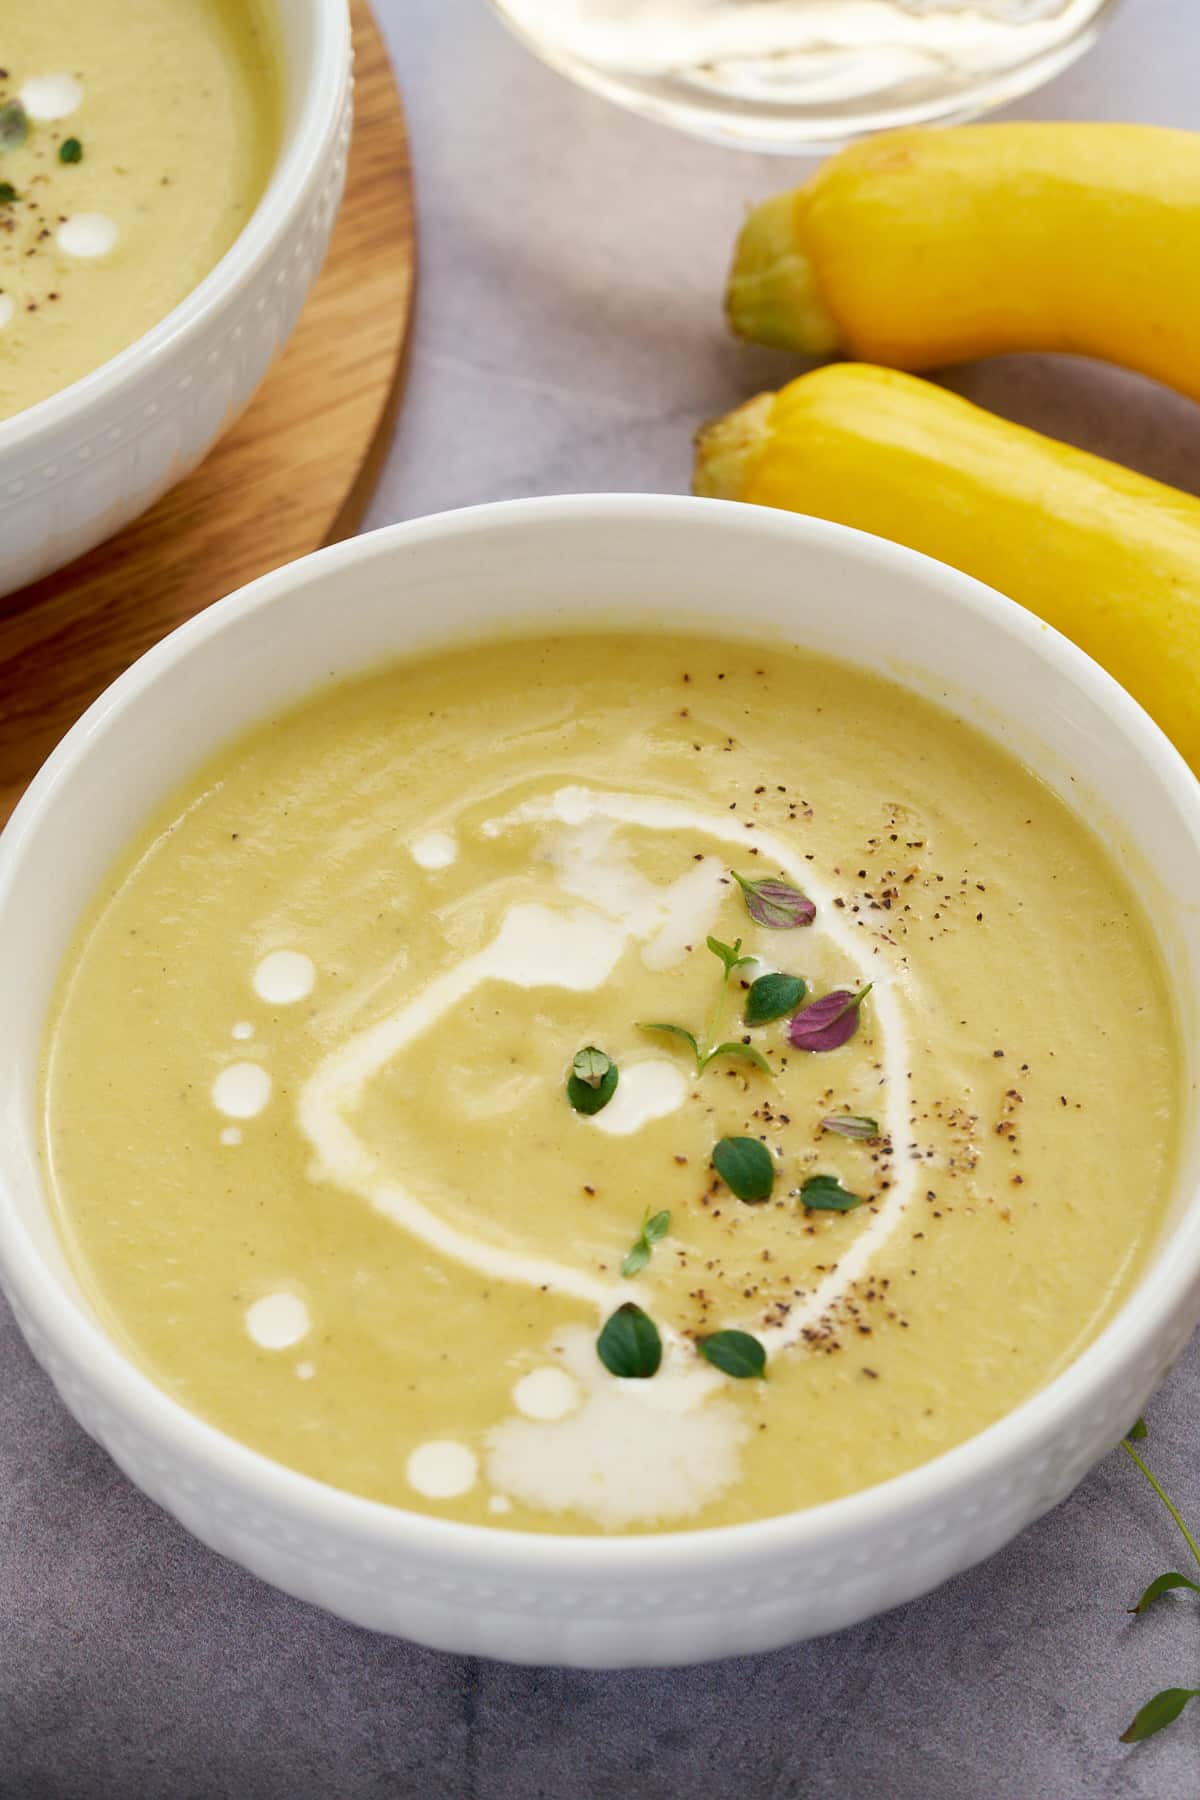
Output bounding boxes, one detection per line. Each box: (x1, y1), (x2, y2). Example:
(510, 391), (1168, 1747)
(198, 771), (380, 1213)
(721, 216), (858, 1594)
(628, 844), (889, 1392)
(727, 124), (1200, 400)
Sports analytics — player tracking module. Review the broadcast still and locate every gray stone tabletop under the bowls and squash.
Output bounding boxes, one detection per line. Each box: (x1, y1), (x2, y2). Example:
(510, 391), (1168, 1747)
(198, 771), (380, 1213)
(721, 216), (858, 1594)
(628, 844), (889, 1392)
(0, 0), (1200, 1800)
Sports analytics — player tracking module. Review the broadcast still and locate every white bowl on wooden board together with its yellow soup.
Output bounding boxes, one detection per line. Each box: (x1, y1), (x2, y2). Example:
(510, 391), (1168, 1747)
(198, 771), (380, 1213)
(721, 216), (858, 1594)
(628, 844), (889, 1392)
(0, 0), (351, 594)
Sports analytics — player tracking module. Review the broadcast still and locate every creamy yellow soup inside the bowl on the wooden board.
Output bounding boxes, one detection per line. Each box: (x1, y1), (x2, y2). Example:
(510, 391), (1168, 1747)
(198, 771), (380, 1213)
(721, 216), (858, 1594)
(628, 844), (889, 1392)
(0, 0), (281, 419)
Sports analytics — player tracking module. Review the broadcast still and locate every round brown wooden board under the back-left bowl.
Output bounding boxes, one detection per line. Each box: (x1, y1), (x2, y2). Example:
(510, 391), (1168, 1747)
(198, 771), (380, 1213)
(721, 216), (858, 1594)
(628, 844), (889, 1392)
(0, 0), (416, 823)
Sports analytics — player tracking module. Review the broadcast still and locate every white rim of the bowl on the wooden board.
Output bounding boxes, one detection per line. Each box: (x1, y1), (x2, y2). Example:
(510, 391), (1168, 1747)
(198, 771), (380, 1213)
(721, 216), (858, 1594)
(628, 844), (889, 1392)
(0, 0), (351, 463)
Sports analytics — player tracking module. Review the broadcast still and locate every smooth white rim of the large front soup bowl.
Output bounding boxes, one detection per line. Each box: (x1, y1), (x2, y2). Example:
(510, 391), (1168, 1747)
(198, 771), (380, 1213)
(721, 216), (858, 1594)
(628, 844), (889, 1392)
(0, 493), (1200, 1580)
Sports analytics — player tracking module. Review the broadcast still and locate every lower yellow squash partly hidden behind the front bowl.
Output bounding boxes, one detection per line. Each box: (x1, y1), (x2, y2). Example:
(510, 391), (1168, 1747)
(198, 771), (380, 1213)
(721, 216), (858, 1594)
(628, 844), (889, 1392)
(694, 364), (1200, 774)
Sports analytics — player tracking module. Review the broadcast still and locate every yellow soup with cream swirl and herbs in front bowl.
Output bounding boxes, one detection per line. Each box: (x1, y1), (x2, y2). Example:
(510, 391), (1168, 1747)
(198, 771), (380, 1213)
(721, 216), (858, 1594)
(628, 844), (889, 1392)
(45, 635), (1178, 1532)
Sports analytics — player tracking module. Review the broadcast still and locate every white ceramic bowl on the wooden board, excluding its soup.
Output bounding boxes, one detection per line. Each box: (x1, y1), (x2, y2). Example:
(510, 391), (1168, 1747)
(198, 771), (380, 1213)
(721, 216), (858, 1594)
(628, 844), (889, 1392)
(0, 0), (351, 596)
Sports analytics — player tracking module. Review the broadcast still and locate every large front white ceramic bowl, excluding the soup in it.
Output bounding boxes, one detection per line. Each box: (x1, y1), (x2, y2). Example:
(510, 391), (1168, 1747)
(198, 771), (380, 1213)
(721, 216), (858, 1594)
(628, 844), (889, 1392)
(0, 495), (1200, 1665)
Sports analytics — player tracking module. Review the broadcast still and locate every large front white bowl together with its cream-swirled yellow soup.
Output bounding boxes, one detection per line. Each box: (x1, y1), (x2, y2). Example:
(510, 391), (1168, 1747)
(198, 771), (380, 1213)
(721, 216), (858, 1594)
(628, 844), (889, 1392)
(0, 497), (1200, 1663)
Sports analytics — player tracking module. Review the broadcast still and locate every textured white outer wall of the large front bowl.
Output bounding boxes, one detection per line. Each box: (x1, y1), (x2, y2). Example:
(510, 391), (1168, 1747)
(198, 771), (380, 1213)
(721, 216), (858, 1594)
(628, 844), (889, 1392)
(5, 1283), (1200, 1669)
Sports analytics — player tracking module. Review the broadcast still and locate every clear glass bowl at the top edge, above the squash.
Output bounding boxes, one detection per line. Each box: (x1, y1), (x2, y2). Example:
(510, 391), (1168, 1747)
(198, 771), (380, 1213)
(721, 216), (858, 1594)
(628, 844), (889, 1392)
(491, 0), (1115, 155)
